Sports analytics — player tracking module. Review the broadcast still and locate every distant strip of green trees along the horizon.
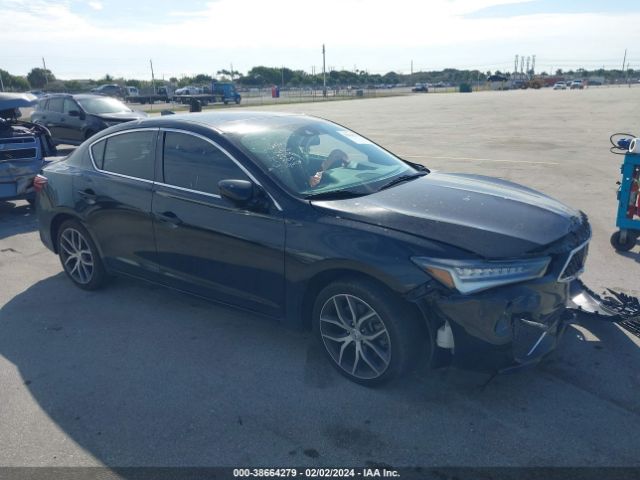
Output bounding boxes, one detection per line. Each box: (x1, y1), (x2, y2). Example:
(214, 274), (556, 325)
(0, 66), (637, 92)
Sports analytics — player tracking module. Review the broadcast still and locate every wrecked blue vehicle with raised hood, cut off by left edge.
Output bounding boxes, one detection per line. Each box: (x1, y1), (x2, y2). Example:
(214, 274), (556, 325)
(0, 93), (56, 203)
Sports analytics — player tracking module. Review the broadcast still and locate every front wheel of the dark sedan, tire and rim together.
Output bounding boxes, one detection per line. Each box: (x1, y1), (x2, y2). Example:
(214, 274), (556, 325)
(313, 279), (420, 386)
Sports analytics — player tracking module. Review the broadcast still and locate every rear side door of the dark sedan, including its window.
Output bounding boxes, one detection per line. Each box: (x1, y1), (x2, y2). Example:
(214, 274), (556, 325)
(78, 128), (158, 279)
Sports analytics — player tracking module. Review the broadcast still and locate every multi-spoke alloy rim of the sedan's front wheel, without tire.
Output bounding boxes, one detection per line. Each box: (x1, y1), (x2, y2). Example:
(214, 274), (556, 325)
(320, 294), (391, 380)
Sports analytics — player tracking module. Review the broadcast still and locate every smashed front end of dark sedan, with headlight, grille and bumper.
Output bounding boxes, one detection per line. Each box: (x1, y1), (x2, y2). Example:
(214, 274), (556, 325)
(412, 214), (601, 373)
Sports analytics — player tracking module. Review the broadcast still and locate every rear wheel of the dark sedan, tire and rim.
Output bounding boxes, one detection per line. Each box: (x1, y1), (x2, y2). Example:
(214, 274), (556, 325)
(57, 220), (107, 290)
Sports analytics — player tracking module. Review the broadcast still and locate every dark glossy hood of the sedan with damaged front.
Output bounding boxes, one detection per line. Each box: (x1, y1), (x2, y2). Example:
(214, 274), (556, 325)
(312, 173), (581, 258)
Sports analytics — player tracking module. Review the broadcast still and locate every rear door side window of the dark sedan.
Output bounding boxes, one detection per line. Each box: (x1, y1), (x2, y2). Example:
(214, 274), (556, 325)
(103, 131), (156, 180)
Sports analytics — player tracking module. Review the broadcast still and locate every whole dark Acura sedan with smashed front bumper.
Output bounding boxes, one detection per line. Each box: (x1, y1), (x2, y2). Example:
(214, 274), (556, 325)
(37, 112), (590, 385)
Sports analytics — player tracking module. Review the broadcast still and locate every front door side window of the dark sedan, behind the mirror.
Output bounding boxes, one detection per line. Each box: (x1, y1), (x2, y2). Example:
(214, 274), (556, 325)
(163, 132), (248, 195)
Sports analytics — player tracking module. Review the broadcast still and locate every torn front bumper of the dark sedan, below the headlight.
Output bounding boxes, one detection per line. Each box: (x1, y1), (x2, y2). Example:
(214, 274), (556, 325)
(414, 275), (592, 373)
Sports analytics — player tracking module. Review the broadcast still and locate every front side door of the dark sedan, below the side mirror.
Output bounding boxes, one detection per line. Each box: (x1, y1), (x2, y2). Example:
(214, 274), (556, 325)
(152, 130), (284, 316)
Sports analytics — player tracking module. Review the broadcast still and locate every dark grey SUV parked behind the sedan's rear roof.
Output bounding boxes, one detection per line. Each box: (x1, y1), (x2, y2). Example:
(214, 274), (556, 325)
(31, 94), (147, 145)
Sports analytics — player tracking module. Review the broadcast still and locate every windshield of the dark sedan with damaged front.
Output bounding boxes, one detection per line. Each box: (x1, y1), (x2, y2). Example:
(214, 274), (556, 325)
(225, 117), (417, 198)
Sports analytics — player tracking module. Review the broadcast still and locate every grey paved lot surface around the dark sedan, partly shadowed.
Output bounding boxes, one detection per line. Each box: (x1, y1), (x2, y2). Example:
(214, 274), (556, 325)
(0, 87), (640, 467)
